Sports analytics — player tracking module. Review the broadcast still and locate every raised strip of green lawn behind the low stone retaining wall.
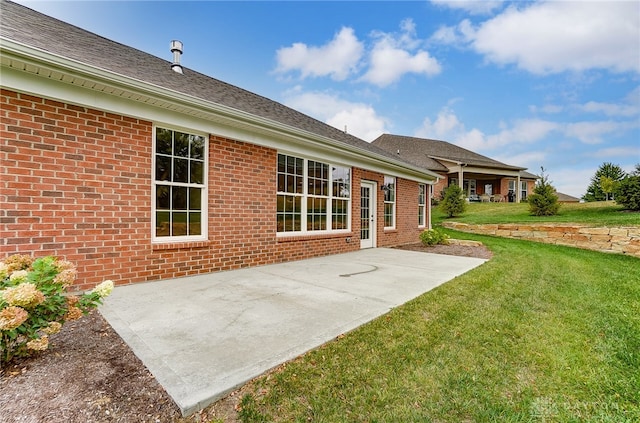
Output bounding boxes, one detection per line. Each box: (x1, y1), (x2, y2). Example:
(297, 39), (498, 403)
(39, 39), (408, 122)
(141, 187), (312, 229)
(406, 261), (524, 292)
(432, 201), (640, 226)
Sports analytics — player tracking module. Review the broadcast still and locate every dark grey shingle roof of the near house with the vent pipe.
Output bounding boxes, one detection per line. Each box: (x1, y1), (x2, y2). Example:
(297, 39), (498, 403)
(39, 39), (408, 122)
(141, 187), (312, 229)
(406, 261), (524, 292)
(0, 0), (420, 171)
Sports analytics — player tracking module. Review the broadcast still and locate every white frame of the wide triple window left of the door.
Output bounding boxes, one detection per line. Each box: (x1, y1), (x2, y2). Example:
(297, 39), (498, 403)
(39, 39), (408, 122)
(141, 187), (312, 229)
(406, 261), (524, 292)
(276, 151), (353, 238)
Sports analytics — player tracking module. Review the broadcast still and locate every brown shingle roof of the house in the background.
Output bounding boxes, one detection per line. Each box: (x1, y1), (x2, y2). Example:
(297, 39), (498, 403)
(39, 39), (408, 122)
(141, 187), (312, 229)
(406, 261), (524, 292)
(372, 134), (536, 177)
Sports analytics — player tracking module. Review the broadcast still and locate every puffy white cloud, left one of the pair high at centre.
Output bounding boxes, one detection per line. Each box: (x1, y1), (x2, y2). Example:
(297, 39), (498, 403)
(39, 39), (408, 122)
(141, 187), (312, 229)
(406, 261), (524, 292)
(276, 27), (364, 81)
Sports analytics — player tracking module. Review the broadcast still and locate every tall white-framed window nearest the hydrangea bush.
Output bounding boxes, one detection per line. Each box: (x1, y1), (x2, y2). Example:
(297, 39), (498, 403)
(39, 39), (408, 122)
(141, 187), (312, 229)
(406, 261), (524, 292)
(152, 126), (207, 242)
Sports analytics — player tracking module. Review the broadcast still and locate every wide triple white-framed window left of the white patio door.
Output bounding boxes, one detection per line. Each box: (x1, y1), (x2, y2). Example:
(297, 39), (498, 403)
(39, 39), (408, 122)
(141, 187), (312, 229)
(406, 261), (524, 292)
(276, 153), (351, 235)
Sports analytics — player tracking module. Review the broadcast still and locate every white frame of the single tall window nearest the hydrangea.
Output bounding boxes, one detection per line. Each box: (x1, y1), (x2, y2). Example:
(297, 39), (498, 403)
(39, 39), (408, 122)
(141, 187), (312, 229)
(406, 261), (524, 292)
(151, 124), (209, 244)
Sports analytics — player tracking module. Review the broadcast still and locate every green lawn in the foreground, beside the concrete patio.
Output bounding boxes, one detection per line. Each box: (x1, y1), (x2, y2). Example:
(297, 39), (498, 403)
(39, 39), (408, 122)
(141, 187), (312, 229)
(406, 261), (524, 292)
(240, 234), (640, 423)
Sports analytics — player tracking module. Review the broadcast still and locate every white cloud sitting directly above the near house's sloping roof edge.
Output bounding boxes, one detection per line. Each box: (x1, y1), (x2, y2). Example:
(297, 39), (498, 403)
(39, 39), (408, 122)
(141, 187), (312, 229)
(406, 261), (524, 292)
(285, 87), (387, 142)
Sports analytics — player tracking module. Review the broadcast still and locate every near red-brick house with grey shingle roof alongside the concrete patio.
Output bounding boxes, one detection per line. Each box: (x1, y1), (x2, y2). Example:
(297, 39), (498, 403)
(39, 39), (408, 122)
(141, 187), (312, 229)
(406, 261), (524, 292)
(0, 0), (437, 289)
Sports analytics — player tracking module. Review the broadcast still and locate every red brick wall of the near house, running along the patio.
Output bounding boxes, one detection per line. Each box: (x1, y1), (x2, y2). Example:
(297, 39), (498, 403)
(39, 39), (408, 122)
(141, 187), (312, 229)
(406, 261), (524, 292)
(0, 90), (428, 290)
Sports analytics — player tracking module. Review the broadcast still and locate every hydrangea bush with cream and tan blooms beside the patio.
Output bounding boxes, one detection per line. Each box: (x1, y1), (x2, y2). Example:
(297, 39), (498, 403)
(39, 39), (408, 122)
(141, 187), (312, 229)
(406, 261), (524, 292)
(0, 254), (113, 365)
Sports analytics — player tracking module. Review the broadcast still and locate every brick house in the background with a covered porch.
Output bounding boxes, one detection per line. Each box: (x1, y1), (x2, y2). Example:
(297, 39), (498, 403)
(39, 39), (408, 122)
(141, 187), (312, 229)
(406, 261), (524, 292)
(372, 134), (538, 202)
